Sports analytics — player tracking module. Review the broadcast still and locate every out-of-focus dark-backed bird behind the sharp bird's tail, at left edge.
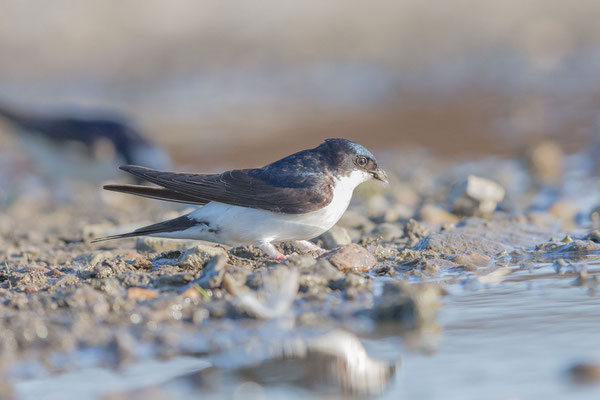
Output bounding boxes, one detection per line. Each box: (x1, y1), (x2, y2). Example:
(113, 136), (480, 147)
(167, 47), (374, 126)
(0, 104), (171, 181)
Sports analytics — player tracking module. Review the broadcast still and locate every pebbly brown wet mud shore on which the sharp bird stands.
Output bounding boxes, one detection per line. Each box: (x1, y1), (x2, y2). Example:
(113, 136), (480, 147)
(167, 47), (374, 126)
(0, 142), (600, 398)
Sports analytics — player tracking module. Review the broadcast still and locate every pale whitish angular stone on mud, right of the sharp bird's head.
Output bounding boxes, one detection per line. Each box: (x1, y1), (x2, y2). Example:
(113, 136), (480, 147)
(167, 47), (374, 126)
(448, 175), (505, 215)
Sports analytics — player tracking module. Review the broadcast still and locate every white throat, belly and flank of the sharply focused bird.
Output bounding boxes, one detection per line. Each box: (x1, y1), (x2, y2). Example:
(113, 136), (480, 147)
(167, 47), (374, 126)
(165, 170), (368, 246)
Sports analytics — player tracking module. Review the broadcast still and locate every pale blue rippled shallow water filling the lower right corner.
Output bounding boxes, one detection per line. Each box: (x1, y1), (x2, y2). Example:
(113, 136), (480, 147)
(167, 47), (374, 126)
(394, 256), (600, 399)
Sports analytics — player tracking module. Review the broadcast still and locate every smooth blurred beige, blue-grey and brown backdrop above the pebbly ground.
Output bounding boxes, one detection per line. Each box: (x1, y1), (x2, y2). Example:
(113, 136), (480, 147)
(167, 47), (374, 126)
(0, 0), (600, 170)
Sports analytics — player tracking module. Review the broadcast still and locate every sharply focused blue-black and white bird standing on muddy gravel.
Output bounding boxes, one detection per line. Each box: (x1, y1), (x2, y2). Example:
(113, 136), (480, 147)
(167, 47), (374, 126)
(93, 138), (388, 261)
